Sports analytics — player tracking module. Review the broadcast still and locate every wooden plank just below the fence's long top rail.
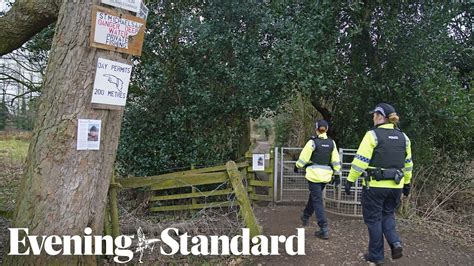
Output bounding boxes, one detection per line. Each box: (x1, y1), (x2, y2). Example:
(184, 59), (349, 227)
(150, 173), (228, 190)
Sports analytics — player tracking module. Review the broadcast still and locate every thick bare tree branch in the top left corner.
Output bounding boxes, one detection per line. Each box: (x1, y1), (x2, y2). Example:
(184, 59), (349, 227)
(0, 0), (62, 56)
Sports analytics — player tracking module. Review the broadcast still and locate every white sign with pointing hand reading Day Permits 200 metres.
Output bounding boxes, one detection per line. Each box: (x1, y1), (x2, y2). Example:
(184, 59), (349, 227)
(91, 58), (132, 106)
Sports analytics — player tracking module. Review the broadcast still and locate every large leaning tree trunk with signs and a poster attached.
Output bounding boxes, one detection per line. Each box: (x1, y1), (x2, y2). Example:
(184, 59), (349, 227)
(5, 0), (129, 265)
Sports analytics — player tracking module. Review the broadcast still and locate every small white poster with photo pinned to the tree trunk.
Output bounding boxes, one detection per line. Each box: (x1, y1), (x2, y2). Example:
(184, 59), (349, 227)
(77, 119), (101, 150)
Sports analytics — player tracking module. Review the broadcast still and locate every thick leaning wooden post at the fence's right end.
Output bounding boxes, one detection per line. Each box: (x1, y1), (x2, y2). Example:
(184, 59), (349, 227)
(226, 161), (262, 237)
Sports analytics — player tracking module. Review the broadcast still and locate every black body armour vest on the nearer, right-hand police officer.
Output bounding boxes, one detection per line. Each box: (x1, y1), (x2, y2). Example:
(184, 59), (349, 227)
(369, 128), (406, 169)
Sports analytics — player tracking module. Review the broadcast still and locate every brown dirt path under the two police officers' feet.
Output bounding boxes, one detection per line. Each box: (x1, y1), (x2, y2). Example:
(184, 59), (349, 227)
(252, 205), (474, 265)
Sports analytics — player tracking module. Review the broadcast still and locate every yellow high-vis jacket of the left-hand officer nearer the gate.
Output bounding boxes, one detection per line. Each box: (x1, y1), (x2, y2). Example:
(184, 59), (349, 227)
(296, 133), (341, 183)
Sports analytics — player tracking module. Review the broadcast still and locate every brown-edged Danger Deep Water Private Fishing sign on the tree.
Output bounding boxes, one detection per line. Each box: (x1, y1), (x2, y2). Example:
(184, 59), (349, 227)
(91, 6), (145, 55)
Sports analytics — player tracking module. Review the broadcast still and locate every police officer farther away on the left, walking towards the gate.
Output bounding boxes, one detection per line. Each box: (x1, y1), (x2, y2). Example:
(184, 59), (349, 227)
(295, 120), (341, 239)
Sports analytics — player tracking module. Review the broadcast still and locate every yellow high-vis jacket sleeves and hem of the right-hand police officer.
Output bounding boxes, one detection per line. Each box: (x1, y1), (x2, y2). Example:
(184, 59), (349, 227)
(347, 123), (413, 188)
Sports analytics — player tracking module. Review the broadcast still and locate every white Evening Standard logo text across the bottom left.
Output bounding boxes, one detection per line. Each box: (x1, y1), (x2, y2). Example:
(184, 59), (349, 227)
(8, 227), (306, 263)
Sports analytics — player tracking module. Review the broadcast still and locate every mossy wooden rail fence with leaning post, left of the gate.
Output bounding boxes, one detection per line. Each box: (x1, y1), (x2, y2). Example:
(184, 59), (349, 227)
(104, 161), (262, 235)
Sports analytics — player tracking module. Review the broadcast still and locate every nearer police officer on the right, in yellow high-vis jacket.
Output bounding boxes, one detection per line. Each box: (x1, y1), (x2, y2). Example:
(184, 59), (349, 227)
(345, 103), (413, 264)
